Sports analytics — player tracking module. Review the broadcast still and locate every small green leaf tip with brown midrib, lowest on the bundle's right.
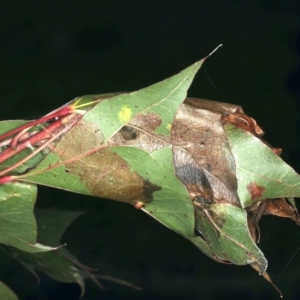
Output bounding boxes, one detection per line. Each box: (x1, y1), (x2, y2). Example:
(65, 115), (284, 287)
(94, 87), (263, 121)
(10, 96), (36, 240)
(195, 203), (268, 273)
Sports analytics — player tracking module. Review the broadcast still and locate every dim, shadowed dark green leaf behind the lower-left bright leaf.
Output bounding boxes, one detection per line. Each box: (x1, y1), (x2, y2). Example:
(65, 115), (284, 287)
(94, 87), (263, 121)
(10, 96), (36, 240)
(5, 209), (100, 295)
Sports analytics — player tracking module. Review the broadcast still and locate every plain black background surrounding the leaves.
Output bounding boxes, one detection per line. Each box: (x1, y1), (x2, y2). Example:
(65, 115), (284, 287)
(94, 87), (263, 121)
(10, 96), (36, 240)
(0, 0), (300, 300)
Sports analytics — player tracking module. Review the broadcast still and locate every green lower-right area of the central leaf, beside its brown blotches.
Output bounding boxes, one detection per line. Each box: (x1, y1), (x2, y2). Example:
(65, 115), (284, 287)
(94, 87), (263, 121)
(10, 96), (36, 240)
(111, 147), (195, 237)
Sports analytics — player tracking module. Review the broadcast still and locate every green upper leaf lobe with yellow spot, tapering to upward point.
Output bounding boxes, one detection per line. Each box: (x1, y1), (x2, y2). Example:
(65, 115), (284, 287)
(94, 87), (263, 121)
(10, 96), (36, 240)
(83, 59), (204, 141)
